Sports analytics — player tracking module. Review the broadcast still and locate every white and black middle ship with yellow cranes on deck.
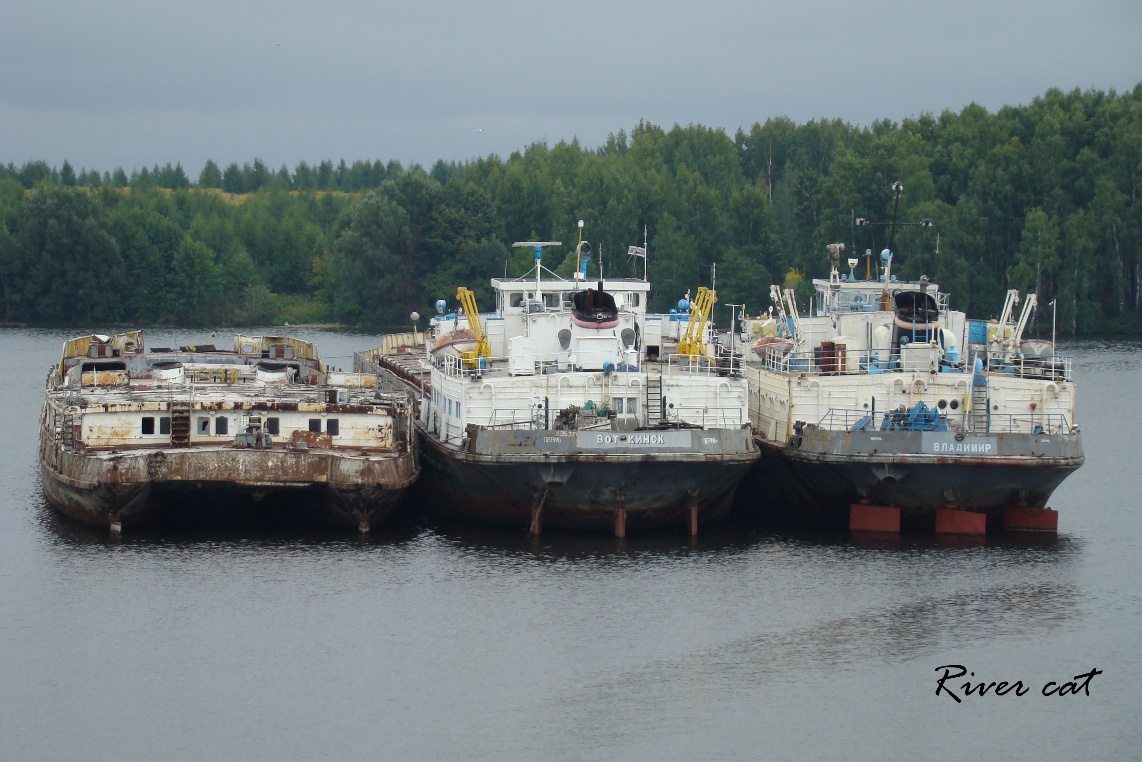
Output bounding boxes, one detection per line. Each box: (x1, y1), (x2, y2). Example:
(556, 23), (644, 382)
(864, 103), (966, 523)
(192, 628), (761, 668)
(357, 229), (758, 536)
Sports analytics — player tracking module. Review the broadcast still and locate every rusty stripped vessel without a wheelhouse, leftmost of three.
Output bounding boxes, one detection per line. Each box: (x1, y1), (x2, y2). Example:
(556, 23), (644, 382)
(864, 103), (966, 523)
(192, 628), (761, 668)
(40, 331), (418, 531)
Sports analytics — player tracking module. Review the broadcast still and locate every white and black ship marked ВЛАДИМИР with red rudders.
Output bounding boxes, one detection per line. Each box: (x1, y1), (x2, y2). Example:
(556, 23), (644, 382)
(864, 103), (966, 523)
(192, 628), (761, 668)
(742, 202), (1084, 534)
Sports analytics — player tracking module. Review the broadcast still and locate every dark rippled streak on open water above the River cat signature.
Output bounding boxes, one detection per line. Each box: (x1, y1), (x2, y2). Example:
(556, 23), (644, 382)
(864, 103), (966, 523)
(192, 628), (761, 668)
(552, 583), (1084, 745)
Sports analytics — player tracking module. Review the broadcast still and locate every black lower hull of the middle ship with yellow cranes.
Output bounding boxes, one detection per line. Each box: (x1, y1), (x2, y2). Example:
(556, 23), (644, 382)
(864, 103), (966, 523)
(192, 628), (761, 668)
(420, 430), (758, 532)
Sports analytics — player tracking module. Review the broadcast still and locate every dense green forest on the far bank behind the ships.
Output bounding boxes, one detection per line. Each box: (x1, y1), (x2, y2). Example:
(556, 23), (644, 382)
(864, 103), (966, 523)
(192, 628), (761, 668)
(0, 83), (1142, 334)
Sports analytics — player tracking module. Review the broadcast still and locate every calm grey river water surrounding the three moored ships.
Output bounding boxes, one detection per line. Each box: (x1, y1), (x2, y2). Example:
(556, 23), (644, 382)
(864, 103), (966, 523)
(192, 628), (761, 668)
(0, 330), (1142, 762)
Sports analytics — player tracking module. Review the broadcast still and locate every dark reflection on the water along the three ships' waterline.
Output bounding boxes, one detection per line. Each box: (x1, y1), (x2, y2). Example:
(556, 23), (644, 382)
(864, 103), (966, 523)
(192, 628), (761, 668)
(31, 482), (1077, 564)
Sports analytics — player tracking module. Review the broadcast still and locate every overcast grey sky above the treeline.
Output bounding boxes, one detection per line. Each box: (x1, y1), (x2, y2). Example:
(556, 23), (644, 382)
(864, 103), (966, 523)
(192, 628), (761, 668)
(0, 0), (1142, 177)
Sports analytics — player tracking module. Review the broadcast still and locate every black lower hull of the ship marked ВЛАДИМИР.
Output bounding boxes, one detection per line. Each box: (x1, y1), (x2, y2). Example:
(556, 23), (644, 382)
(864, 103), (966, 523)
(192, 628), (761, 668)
(738, 430), (1084, 530)
